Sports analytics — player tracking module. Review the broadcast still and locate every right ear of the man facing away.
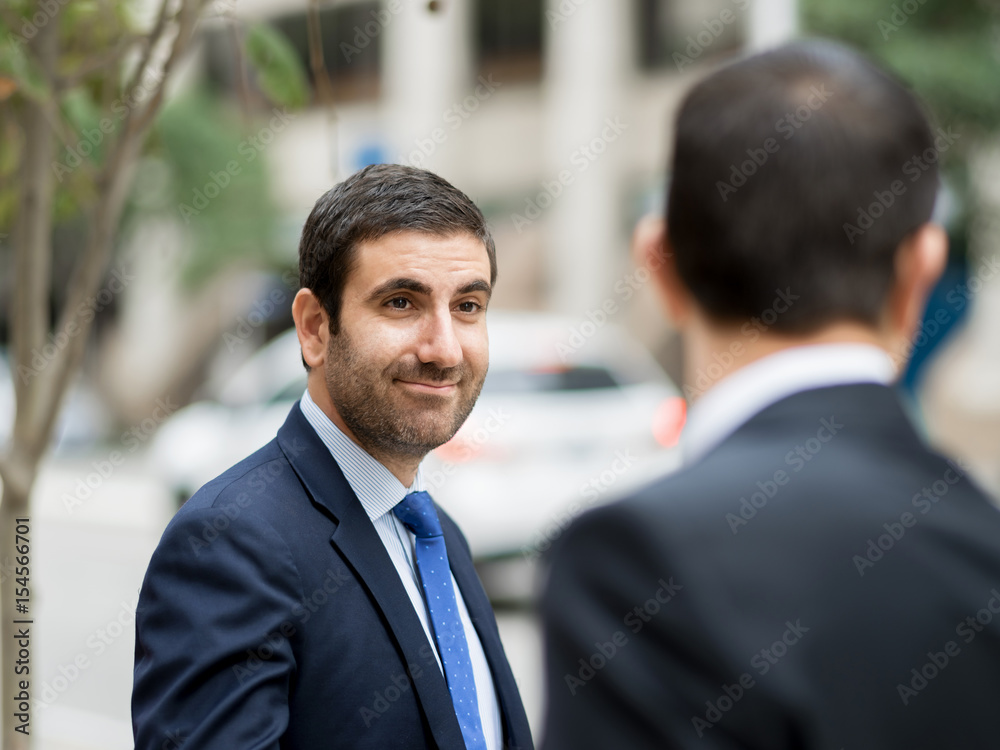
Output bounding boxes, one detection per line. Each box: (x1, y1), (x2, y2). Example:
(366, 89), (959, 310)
(886, 223), (948, 341)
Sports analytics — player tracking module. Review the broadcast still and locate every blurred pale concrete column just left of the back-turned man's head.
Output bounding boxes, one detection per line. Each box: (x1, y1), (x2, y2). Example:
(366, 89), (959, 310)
(535, 0), (633, 315)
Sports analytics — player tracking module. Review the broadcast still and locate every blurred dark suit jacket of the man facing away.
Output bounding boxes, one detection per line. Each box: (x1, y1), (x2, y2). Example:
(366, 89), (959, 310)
(542, 385), (1000, 750)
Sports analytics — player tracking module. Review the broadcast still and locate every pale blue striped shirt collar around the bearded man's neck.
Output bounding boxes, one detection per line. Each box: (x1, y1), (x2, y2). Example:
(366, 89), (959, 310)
(299, 388), (423, 521)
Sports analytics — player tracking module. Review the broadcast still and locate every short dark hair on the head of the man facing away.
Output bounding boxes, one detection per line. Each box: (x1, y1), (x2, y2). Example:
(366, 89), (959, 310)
(665, 40), (949, 335)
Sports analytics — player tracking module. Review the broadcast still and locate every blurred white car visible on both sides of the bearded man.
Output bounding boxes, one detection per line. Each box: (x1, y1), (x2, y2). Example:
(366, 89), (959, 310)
(150, 311), (686, 560)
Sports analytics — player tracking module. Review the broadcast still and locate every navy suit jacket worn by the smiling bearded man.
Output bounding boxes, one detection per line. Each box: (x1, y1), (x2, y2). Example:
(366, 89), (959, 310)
(132, 404), (532, 750)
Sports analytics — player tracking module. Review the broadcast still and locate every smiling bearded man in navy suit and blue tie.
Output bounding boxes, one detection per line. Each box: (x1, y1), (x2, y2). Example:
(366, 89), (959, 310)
(132, 165), (532, 750)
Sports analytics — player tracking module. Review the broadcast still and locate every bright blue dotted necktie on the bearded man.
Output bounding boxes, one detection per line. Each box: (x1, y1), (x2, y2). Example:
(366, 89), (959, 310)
(392, 492), (486, 750)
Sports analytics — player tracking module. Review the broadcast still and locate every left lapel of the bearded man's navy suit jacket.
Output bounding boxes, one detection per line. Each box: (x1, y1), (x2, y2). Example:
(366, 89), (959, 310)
(278, 404), (465, 750)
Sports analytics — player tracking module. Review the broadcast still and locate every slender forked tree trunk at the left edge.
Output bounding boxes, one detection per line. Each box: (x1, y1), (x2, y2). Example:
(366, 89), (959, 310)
(0, 0), (215, 750)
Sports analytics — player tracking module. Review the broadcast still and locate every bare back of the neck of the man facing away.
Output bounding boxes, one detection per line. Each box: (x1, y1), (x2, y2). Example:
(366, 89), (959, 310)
(684, 316), (894, 397)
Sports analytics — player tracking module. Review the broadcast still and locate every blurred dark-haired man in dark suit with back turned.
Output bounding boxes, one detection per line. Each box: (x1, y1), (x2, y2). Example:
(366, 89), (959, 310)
(542, 41), (1000, 750)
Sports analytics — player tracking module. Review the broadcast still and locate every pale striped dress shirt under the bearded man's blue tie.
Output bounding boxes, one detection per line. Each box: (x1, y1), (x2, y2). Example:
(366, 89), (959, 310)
(300, 389), (503, 750)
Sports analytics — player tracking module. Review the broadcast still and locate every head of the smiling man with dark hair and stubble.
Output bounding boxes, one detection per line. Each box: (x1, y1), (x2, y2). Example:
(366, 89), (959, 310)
(292, 165), (496, 476)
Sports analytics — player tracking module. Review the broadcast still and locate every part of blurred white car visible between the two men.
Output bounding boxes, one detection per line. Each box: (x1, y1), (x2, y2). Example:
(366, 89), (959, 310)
(424, 313), (686, 559)
